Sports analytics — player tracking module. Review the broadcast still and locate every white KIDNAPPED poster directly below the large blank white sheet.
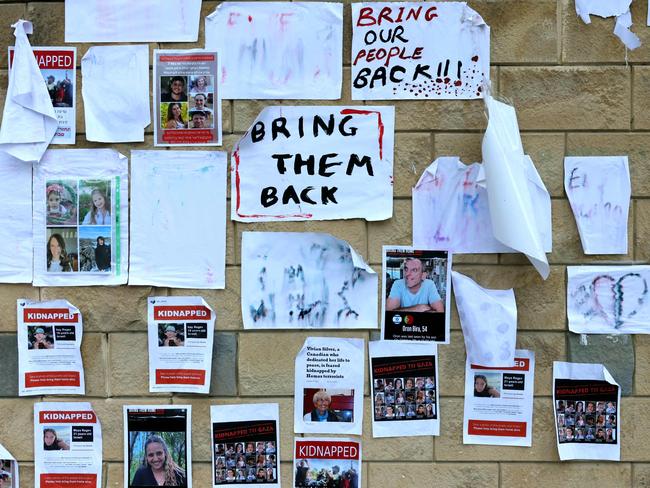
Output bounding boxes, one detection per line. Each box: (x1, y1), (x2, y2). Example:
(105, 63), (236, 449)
(148, 297), (216, 393)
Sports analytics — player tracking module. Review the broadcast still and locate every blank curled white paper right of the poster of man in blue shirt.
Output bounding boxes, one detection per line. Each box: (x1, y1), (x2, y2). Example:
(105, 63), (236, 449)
(451, 271), (517, 367)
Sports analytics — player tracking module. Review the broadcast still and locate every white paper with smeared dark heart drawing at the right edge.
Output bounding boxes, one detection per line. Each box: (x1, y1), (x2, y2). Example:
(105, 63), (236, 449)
(567, 266), (650, 334)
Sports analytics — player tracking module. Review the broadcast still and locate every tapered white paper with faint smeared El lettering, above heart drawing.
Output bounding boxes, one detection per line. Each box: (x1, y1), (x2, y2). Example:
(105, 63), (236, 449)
(564, 156), (632, 254)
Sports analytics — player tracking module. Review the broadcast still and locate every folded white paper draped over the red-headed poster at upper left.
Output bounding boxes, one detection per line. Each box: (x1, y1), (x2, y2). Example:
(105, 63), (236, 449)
(0, 19), (59, 162)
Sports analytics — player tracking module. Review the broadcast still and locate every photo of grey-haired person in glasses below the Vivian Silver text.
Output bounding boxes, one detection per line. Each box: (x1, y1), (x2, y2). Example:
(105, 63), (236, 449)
(303, 388), (354, 422)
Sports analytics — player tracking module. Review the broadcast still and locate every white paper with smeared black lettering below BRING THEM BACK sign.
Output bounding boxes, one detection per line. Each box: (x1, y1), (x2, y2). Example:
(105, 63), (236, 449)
(241, 232), (378, 329)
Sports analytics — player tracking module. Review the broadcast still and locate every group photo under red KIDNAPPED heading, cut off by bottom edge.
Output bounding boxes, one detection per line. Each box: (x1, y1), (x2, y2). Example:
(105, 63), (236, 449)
(294, 459), (360, 488)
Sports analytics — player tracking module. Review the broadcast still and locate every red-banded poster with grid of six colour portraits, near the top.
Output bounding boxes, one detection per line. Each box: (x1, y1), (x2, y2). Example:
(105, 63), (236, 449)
(153, 49), (221, 146)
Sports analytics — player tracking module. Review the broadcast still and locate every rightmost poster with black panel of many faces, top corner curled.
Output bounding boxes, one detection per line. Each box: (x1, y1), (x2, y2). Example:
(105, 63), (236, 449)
(553, 361), (621, 461)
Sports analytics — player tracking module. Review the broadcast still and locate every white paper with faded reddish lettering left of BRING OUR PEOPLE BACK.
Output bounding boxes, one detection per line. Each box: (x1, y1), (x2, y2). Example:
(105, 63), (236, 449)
(205, 1), (343, 100)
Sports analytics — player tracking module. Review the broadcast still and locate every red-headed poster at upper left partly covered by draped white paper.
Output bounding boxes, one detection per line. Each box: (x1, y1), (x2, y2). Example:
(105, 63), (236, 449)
(9, 46), (77, 144)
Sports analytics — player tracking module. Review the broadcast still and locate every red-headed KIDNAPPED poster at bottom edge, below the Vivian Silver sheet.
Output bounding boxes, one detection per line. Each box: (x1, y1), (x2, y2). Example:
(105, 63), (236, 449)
(293, 437), (362, 488)
